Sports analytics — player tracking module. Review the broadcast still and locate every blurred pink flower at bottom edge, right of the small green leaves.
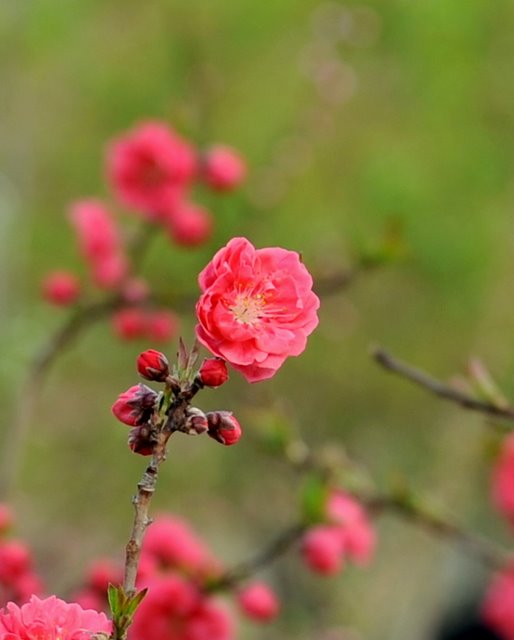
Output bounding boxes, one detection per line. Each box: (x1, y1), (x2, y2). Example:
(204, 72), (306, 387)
(129, 575), (233, 640)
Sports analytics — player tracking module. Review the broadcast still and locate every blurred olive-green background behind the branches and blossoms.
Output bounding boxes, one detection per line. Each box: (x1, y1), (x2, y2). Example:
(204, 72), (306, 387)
(0, 0), (514, 640)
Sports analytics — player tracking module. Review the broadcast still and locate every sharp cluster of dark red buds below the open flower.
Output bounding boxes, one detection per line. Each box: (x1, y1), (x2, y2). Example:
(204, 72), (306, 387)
(112, 341), (241, 456)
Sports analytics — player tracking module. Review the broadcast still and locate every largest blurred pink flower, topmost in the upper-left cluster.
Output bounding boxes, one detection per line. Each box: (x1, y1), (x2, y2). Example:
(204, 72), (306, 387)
(107, 122), (196, 220)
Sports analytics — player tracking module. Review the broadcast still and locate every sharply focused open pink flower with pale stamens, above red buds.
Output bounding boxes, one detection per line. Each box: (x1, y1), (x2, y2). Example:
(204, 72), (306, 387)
(196, 238), (319, 382)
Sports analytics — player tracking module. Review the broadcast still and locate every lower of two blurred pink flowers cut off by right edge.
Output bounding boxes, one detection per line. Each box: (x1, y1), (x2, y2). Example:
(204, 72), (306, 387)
(482, 565), (514, 640)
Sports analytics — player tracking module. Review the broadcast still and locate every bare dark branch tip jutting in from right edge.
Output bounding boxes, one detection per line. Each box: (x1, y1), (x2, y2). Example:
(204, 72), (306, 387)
(372, 347), (514, 421)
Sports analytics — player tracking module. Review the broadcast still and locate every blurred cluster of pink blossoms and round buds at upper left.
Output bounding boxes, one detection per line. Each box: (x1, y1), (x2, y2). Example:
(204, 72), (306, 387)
(42, 121), (246, 342)
